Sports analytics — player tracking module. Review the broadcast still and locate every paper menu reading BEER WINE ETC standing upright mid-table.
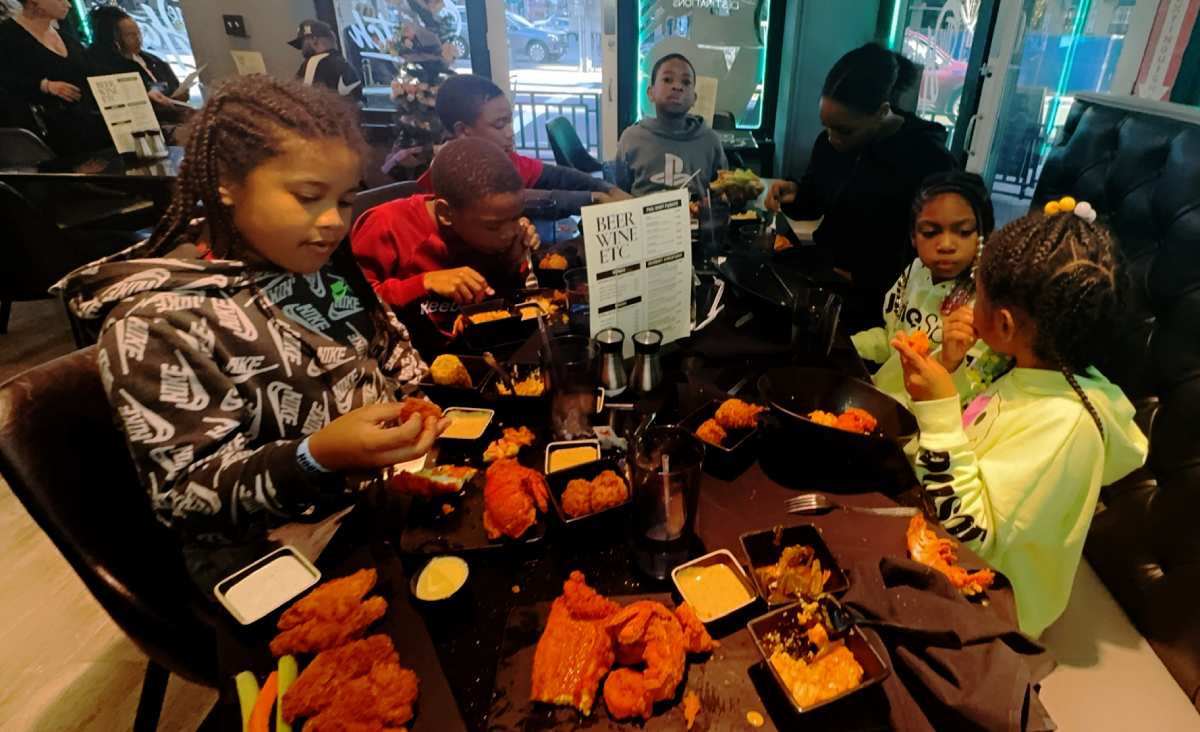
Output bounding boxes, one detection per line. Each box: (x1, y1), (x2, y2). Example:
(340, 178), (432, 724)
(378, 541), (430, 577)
(581, 190), (692, 358)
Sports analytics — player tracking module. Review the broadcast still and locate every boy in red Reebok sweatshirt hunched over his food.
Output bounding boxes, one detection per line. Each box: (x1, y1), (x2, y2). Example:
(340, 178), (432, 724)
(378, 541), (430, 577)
(350, 138), (540, 355)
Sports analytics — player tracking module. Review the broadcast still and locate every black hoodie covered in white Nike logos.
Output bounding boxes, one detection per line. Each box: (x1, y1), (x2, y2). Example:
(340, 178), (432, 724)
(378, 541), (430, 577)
(55, 234), (425, 587)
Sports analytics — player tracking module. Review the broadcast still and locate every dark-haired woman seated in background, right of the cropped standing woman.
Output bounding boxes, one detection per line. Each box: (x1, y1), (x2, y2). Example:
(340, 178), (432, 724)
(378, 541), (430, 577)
(88, 5), (186, 122)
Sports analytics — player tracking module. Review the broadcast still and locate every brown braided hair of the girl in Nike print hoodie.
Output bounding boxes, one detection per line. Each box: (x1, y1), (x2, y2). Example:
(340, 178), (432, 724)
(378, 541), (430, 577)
(149, 74), (365, 257)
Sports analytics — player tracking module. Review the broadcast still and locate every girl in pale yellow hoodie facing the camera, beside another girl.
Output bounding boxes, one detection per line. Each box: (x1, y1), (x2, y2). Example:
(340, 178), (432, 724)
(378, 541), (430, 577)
(851, 170), (1009, 403)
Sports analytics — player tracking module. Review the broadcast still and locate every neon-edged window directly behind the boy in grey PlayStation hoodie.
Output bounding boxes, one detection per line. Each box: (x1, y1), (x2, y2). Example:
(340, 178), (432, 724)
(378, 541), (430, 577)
(637, 0), (772, 130)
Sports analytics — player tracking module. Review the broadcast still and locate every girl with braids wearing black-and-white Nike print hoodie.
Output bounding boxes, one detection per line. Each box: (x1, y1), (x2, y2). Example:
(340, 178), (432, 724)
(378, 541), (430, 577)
(56, 76), (445, 589)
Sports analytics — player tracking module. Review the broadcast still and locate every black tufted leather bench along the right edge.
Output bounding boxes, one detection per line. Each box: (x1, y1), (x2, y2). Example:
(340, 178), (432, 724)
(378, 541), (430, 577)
(1033, 95), (1200, 709)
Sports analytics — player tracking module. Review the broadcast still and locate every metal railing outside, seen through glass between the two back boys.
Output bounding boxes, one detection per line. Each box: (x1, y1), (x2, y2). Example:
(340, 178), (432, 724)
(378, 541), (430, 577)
(512, 85), (604, 162)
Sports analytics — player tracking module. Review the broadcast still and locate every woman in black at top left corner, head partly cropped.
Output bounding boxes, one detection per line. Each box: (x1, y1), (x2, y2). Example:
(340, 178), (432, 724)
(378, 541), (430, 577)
(0, 0), (112, 155)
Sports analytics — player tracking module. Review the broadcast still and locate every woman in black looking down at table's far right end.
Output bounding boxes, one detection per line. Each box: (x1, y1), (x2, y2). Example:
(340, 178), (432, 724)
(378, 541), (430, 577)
(767, 43), (955, 329)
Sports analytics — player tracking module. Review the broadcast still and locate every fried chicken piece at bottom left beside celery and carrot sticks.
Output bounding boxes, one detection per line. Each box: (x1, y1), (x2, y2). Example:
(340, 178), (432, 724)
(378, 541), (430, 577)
(283, 635), (400, 722)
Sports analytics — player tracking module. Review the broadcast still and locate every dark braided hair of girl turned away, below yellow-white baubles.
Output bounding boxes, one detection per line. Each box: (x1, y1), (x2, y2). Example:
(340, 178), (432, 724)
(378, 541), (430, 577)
(978, 206), (1117, 438)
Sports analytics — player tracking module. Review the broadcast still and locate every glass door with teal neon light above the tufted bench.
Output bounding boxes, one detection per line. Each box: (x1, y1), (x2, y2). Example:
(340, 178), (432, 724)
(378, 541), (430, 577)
(967, 0), (1157, 224)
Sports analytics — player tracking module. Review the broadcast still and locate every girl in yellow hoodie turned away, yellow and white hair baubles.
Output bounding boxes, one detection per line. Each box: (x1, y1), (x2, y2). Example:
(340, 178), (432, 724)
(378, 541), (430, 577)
(893, 199), (1147, 636)
